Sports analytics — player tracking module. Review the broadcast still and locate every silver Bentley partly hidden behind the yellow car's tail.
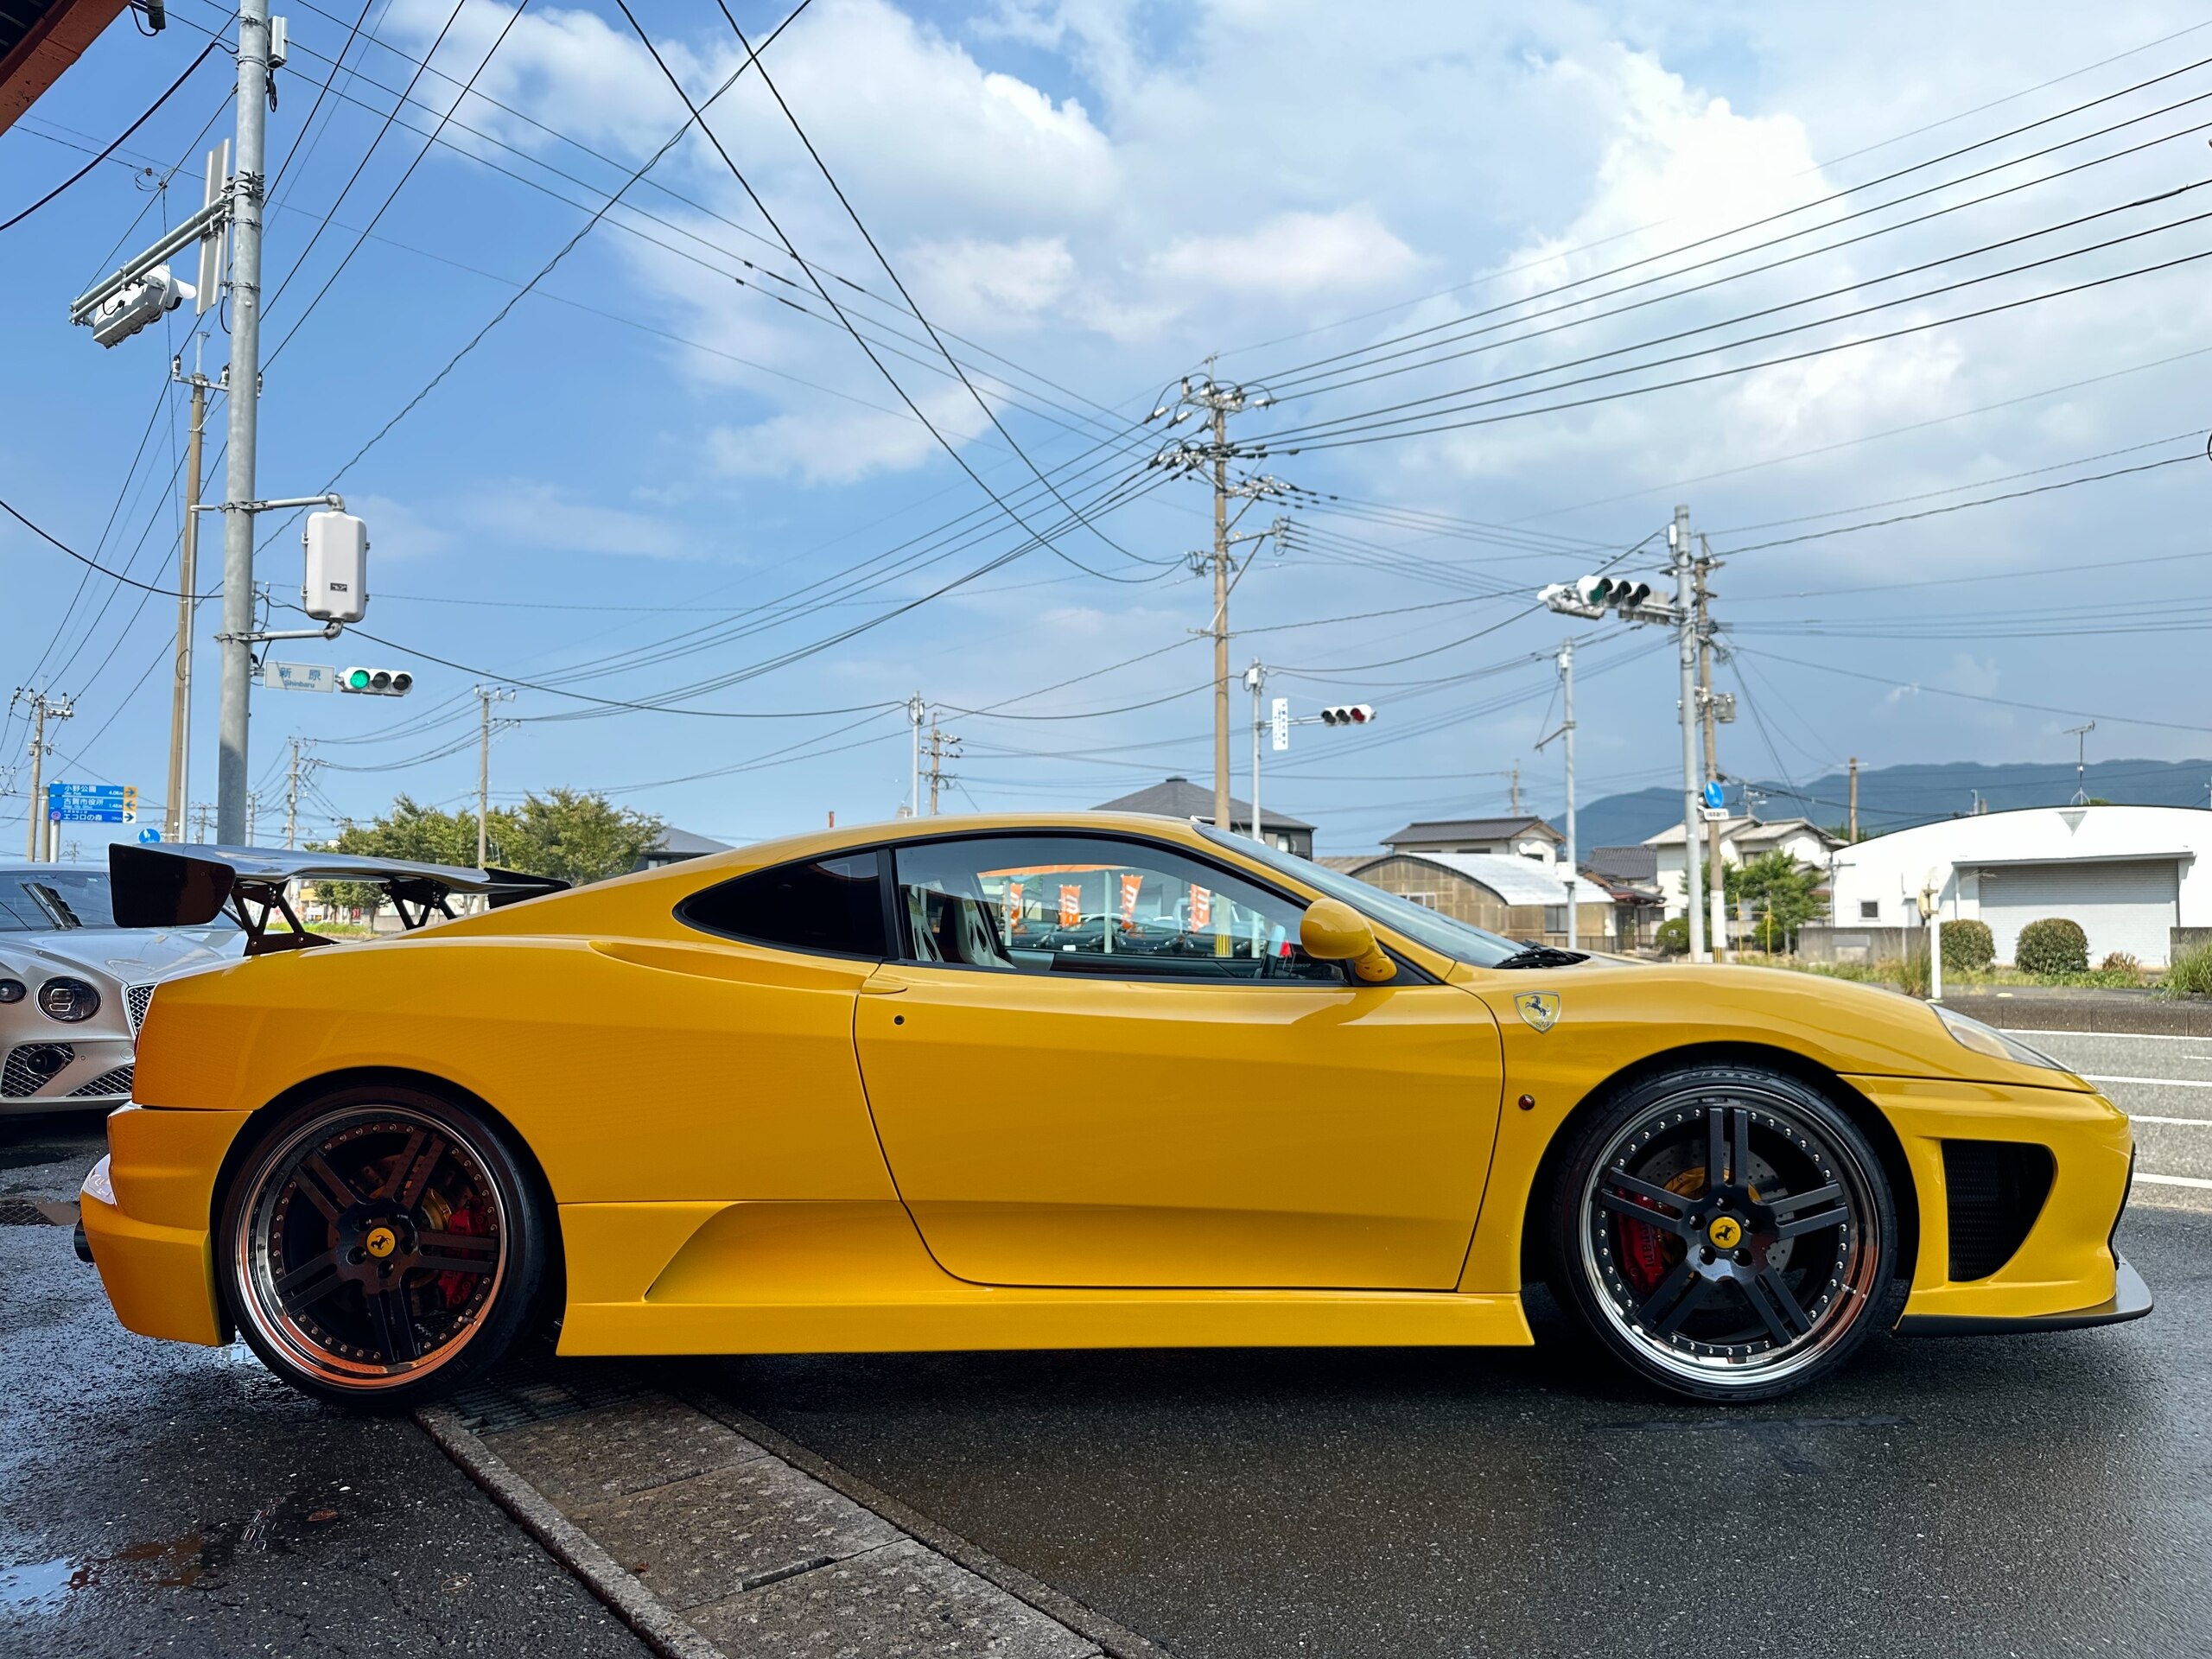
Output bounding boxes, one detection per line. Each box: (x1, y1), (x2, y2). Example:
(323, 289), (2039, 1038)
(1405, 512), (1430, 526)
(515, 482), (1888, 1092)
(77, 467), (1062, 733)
(0, 862), (245, 1115)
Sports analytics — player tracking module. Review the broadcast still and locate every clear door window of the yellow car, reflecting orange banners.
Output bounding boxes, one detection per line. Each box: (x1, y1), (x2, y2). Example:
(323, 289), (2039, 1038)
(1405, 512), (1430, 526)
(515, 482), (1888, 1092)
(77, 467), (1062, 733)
(892, 836), (1343, 982)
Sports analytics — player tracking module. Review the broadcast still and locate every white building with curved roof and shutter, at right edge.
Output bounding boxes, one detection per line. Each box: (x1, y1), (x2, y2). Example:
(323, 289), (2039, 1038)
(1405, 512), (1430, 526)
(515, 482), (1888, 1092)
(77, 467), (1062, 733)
(1829, 807), (2212, 967)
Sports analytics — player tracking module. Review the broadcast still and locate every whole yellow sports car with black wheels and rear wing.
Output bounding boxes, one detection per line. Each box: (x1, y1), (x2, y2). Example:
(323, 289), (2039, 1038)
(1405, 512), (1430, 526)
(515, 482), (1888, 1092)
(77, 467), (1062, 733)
(82, 814), (2150, 1405)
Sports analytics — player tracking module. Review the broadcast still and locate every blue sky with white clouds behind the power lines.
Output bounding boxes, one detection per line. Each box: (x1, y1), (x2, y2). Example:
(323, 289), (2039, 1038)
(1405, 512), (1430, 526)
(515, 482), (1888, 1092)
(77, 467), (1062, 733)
(13, 0), (2212, 852)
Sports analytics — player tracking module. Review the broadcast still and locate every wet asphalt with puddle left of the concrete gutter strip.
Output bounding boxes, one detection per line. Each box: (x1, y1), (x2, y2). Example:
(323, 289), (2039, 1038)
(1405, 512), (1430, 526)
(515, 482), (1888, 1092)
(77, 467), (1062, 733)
(0, 1117), (646, 1659)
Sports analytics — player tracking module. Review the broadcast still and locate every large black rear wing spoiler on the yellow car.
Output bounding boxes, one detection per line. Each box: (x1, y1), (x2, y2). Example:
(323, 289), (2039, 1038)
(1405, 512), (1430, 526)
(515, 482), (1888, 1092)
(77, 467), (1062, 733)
(108, 841), (569, 956)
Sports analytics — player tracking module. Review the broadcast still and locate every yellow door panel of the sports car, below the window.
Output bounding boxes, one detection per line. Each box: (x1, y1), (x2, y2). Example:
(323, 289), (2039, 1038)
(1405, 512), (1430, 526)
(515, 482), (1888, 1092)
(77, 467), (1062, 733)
(854, 967), (1500, 1289)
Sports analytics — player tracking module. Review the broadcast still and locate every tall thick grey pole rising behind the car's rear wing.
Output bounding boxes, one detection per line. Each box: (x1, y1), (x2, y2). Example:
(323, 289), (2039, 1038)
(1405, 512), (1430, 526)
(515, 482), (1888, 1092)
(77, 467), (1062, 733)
(214, 0), (270, 842)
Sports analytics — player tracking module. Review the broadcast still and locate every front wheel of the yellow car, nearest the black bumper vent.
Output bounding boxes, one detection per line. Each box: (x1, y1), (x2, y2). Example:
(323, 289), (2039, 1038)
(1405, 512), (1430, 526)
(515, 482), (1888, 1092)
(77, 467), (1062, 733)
(1548, 1066), (1911, 1402)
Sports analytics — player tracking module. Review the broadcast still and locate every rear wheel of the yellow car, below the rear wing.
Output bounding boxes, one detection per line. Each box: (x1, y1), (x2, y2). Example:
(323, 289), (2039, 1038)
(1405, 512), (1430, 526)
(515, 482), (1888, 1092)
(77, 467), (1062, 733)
(214, 1084), (553, 1411)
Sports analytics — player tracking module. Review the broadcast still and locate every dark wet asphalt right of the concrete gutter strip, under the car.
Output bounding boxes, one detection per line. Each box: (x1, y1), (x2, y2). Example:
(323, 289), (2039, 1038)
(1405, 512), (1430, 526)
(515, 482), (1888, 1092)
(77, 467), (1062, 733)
(712, 1210), (2212, 1659)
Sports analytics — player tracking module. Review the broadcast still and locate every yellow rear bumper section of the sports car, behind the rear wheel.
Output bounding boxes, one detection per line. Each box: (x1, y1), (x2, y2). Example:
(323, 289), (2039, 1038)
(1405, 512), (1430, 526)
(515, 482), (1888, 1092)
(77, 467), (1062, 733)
(78, 1106), (248, 1347)
